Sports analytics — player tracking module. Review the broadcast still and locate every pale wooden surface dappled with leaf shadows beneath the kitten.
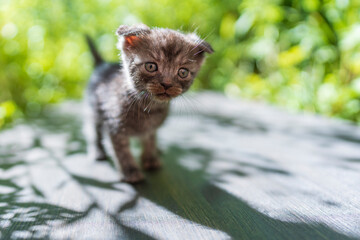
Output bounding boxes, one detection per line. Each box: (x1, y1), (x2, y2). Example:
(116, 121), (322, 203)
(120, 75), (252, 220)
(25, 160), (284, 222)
(0, 93), (360, 239)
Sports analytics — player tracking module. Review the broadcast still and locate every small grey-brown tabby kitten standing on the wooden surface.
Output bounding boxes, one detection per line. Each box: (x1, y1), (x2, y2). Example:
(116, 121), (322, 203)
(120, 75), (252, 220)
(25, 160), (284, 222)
(88, 24), (213, 183)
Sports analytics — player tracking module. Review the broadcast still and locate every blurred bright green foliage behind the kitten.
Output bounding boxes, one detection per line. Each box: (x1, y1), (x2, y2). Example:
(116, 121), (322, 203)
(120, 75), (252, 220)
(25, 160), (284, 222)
(0, 0), (360, 128)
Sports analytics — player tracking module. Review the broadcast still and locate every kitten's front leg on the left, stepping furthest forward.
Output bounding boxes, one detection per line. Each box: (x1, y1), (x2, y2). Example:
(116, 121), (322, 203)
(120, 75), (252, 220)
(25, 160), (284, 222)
(111, 133), (144, 183)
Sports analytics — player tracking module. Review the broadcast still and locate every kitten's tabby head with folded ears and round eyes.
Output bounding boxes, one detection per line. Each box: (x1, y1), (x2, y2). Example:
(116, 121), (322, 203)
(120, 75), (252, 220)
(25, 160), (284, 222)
(117, 24), (213, 101)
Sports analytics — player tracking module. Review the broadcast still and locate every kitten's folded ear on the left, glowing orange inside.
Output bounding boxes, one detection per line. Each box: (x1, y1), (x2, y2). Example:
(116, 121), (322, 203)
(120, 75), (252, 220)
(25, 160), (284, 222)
(116, 24), (150, 47)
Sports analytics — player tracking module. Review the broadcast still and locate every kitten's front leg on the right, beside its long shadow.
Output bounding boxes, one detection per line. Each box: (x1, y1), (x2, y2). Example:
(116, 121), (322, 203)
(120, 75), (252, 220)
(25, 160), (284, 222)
(141, 132), (161, 170)
